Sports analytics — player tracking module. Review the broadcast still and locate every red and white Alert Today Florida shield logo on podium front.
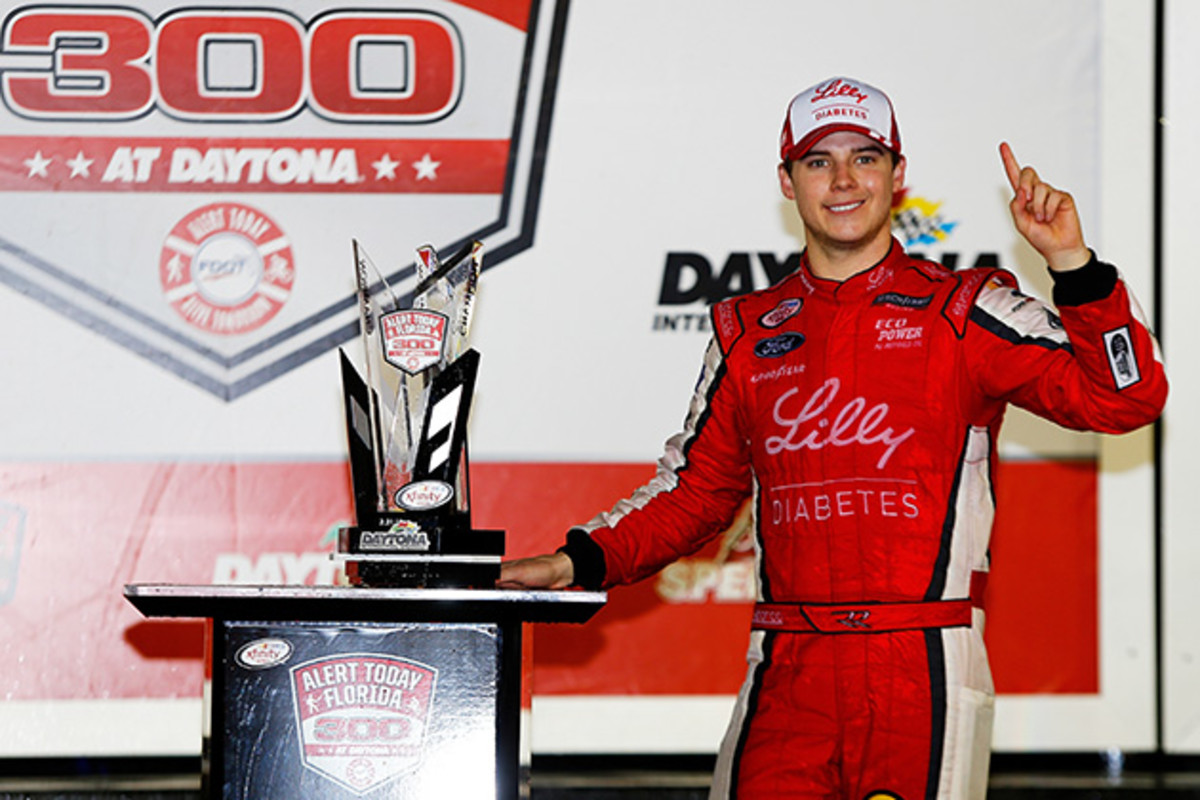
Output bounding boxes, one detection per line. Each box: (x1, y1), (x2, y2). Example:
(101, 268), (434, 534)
(292, 654), (438, 795)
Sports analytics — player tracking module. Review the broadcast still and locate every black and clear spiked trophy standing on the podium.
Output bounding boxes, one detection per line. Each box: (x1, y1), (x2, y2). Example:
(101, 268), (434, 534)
(334, 241), (504, 588)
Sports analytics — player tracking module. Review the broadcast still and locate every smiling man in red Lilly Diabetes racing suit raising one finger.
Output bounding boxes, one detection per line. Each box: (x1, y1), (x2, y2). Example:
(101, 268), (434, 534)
(499, 78), (1166, 800)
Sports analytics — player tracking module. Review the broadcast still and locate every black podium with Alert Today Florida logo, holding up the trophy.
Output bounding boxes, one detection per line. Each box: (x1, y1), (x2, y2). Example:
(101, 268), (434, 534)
(125, 584), (606, 800)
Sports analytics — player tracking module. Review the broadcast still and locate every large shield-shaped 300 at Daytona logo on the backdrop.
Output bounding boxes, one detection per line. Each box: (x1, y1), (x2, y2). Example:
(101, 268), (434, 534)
(0, 0), (568, 401)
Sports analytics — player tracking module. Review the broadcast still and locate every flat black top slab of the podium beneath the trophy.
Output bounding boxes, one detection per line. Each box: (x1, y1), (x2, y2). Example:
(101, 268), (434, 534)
(125, 583), (607, 622)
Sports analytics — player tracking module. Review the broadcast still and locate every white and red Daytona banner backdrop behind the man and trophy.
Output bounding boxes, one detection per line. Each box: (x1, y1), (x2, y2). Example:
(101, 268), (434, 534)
(0, 0), (1152, 756)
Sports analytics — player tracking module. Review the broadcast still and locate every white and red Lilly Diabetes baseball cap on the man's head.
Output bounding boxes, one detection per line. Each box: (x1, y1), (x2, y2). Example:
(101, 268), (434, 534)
(779, 78), (900, 161)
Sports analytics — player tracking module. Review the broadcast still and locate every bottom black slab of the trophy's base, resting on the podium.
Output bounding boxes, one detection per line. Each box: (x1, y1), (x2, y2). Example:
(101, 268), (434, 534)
(334, 554), (500, 589)
